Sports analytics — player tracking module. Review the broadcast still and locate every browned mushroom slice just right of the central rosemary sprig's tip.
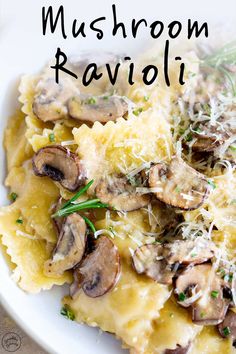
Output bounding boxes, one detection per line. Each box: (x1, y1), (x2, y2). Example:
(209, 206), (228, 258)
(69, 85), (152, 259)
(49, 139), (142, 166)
(95, 176), (150, 211)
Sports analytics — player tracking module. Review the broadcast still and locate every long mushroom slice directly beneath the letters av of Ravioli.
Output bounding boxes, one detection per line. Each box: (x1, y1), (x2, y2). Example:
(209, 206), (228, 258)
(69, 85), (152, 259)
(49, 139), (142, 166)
(68, 95), (129, 123)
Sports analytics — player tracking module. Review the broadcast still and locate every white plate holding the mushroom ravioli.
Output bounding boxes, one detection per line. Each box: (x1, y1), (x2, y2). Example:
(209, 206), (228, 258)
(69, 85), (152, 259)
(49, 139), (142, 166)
(0, 0), (236, 354)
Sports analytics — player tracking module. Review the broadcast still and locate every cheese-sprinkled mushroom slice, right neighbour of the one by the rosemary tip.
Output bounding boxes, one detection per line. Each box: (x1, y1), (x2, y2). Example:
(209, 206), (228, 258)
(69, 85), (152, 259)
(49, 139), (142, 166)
(149, 157), (209, 210)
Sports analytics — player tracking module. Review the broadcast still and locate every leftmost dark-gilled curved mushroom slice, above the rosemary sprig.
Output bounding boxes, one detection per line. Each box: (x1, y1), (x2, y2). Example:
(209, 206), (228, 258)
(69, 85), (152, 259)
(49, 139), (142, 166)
(33, 145), (85, 192)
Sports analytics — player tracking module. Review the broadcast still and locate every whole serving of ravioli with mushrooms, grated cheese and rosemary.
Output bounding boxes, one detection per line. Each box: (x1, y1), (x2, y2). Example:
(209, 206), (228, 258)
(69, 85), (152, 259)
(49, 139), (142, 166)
(0, 42), (236, 354)
